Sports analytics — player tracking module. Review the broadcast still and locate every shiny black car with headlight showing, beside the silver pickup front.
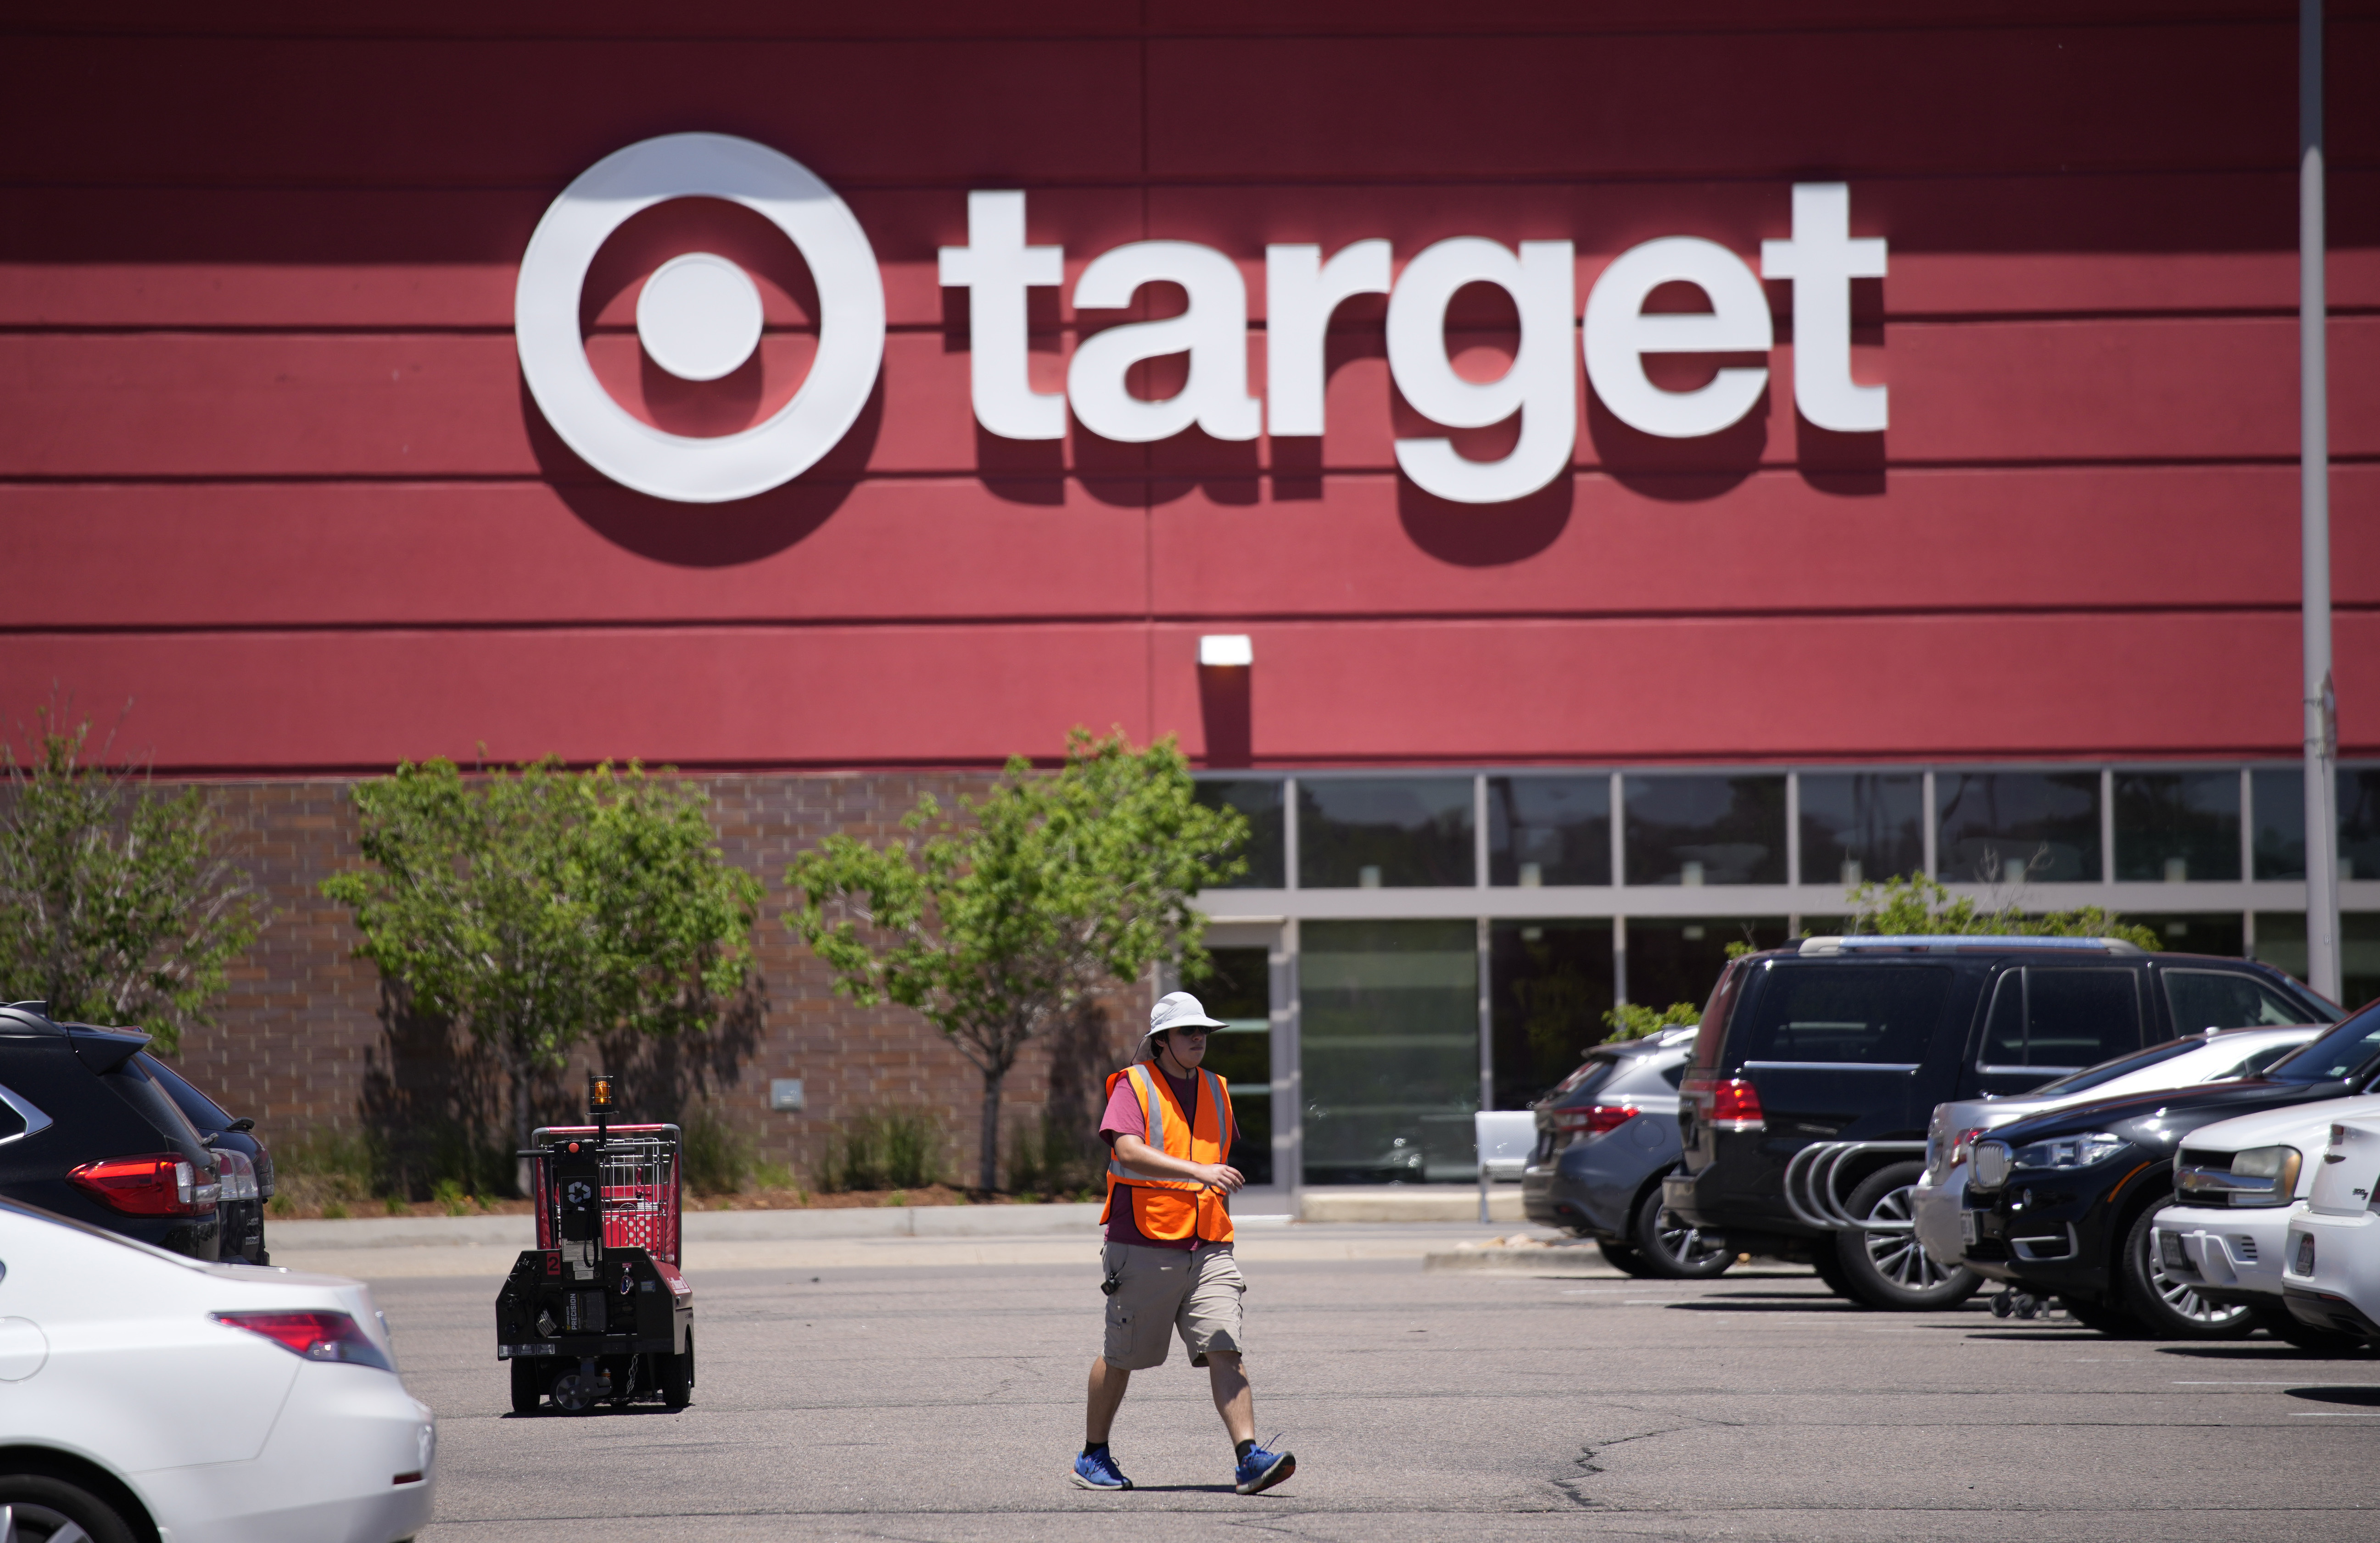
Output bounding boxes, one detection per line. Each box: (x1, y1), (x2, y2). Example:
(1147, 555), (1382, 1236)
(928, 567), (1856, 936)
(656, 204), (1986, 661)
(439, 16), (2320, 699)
(1963, 1007), (2380, 1338)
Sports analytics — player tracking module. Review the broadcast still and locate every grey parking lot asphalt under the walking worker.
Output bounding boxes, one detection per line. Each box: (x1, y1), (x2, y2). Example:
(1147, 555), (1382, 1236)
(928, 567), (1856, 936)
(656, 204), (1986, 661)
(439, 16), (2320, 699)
(357, 1229), (2380, 1543)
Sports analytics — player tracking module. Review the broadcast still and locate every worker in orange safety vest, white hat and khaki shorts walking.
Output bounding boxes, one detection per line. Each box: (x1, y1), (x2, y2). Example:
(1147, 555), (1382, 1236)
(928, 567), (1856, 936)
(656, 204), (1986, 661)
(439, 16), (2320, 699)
(1073, 991), (1297, 1495)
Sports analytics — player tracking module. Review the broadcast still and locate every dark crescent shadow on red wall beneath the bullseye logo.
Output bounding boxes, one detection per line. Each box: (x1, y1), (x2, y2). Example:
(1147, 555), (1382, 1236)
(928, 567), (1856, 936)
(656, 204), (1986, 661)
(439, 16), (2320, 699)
(521, 374), (885, 569)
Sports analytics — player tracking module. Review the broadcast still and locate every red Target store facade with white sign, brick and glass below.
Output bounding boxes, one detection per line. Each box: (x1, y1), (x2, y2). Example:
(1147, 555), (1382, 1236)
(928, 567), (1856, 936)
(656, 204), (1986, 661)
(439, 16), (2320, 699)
(0, 0), (2380, 1186)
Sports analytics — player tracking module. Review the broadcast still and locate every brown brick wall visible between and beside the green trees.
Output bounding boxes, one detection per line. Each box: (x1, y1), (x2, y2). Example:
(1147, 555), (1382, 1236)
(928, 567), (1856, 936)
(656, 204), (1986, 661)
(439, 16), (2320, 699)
(163, 772), (1147, 1179)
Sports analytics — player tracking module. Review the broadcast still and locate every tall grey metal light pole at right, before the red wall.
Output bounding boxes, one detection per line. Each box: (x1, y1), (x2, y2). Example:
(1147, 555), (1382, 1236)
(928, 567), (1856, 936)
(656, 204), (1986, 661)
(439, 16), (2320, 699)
(2296, 0), (2340, 1000)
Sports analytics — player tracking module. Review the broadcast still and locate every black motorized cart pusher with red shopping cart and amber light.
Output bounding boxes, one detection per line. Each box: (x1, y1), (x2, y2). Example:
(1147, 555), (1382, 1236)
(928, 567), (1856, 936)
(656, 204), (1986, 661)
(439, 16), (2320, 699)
(495, 1074), (695, 1415)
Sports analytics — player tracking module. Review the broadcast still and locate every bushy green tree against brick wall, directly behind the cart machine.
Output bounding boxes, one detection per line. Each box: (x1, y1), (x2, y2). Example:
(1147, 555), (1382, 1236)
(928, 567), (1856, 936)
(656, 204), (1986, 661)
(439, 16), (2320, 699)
(321, 760), (762, 1145)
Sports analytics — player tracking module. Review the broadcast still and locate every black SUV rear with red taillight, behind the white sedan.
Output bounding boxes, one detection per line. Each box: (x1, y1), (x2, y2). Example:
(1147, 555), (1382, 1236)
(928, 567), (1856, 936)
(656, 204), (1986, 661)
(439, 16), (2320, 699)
(0, 1003), (223, 1259)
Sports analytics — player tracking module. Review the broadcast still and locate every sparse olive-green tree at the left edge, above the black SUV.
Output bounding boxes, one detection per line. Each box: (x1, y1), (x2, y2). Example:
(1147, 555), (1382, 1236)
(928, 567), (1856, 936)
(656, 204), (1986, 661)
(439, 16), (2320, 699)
(0, 710), (269, 1050)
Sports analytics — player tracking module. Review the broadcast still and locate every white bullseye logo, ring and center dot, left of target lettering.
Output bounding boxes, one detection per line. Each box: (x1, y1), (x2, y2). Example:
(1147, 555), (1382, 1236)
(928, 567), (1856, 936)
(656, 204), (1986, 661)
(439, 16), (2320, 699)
(512, 134), (885, 502)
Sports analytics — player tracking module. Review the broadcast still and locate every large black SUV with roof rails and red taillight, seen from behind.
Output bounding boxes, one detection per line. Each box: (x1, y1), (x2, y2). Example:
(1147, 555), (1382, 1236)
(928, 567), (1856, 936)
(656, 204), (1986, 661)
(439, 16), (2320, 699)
(1664, 936), (2335, 1307)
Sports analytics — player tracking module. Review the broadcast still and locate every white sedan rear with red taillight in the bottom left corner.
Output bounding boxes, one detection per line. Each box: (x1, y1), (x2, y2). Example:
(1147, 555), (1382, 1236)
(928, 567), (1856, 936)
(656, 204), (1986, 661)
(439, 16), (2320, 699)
(0, 1200), (438, 1543)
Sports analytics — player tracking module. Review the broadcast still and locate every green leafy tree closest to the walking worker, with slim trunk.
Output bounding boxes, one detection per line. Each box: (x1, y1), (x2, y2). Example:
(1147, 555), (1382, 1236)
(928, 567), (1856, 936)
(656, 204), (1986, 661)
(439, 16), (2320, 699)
(785, 729), (1247, 1191)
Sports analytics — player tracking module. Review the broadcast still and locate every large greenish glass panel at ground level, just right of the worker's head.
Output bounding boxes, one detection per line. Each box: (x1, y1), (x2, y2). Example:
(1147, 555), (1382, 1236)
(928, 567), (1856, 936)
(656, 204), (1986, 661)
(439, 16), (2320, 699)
(1297, 921), (1481, 1183)
